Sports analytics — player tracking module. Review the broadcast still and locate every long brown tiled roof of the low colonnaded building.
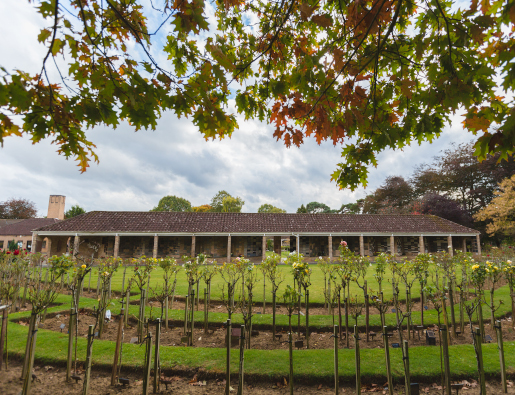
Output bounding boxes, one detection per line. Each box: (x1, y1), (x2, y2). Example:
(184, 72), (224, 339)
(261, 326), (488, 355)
(34, 211), (478, 234)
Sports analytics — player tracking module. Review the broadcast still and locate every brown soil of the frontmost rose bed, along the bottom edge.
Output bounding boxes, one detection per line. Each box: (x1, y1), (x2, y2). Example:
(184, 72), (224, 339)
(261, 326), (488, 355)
(0, 364), (515, 395)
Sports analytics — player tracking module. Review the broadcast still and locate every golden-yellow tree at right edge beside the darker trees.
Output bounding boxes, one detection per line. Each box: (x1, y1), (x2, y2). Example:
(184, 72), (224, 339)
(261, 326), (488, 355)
(474, 175), (515, 236)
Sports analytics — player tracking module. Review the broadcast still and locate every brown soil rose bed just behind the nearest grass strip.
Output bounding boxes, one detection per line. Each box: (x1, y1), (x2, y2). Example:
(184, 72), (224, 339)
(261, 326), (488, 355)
(32, 312), (515, 350)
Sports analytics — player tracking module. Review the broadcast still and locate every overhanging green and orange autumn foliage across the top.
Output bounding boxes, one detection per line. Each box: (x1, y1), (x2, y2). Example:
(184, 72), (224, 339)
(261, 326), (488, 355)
(0, 0), (515, 189)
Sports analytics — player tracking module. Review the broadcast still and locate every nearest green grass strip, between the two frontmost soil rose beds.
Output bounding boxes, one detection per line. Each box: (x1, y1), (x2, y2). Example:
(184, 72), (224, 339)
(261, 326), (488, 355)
(5, 295), (515, 383)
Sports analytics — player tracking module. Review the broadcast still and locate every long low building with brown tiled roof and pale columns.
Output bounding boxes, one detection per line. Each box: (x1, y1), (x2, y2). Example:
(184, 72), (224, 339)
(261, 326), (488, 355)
(34, 211), (481, 261)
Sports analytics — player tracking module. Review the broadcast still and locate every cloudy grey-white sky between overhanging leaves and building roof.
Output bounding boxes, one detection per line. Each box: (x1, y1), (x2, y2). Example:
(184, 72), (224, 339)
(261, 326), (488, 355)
(0, 0), (471, 216)
